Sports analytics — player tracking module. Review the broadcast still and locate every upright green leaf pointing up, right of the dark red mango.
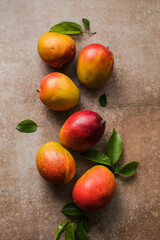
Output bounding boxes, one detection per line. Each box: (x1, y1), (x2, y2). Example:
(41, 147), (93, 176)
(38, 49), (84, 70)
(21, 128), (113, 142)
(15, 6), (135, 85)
(108, 128), (122, 165)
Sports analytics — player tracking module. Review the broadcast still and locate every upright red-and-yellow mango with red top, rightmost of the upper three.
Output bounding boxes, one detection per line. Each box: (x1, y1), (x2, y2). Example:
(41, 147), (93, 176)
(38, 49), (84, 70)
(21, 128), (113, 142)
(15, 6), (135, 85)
(77, 43), (114, 88)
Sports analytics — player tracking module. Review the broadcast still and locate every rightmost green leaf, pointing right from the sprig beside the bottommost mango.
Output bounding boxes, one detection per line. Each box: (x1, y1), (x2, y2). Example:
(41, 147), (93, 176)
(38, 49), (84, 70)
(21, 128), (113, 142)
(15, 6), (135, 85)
(118, 162), (139, 177)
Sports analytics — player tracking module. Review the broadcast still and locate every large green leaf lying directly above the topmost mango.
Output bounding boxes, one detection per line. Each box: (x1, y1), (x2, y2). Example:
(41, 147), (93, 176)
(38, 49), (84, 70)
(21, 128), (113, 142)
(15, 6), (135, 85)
(49, 22), (82, 34)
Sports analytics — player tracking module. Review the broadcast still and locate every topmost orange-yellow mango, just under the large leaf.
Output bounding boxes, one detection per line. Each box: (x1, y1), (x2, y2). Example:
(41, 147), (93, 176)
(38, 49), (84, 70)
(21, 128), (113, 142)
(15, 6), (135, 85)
(37, 32), (76, 68)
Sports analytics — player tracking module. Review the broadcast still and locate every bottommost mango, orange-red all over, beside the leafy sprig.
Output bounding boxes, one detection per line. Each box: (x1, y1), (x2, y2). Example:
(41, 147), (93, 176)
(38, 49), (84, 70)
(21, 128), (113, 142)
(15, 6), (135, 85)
(72, 165), (116, 211)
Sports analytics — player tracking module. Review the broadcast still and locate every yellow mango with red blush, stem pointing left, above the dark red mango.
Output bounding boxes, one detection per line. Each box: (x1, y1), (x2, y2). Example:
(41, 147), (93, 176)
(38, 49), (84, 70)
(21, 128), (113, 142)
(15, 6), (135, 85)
(38, 72), (80, 111)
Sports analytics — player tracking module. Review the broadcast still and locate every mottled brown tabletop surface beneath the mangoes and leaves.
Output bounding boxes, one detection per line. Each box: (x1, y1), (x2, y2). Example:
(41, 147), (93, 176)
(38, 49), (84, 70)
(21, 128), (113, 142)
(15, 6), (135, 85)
(0, 0), (160, 240)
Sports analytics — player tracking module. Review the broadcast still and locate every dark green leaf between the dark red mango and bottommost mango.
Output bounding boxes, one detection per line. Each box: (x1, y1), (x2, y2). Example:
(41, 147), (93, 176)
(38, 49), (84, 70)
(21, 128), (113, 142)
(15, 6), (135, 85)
(81, 149), (111, 165)
